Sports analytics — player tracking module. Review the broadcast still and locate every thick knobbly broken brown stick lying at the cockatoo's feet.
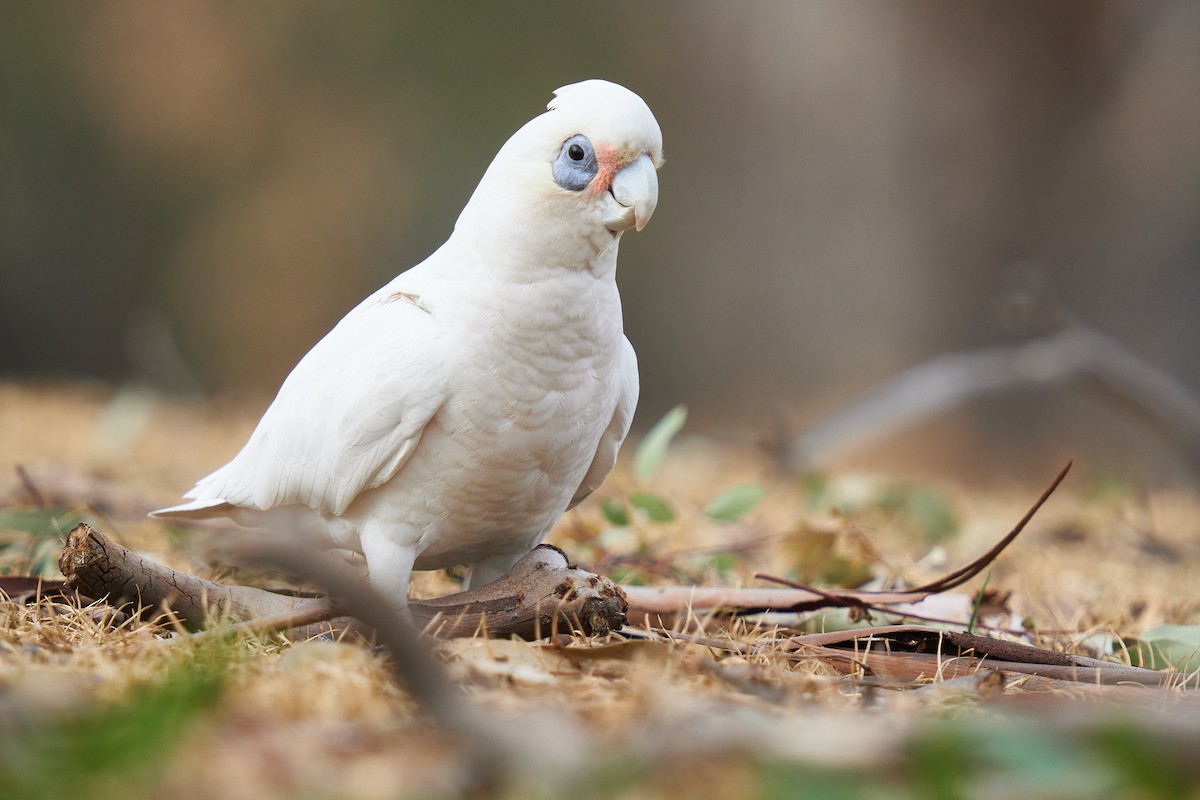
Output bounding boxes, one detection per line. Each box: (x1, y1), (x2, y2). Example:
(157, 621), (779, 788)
(59, 524), (626, 638)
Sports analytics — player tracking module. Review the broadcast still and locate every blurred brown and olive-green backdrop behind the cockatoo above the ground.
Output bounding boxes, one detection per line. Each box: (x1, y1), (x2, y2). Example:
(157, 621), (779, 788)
(0, 0), (1200, 483)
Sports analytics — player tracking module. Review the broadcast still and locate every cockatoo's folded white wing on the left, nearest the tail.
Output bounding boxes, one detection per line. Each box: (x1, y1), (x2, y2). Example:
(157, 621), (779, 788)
(167, 287), (455, 515)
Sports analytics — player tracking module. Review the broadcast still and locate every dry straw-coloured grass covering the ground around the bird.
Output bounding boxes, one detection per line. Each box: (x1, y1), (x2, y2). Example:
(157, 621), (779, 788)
(0, 385), (1200, 799)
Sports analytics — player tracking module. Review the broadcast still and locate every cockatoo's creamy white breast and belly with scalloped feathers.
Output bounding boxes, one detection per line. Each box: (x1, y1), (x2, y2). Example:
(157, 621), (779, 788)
(367, 268), (624, 563)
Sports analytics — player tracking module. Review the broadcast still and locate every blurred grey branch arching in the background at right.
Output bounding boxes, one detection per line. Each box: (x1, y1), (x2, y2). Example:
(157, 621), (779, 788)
(786, 325), (1200, 469)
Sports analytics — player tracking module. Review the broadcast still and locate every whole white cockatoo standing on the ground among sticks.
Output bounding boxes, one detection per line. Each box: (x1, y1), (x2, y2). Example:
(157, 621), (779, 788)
(154, 80), (662, 608)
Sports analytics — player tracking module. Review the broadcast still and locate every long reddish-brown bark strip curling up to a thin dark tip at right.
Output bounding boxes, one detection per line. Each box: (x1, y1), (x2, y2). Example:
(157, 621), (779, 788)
(622, 462), (1073, 627)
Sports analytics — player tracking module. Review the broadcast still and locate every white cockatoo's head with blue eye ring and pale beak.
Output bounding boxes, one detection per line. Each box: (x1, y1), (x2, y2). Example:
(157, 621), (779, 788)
(457, 80), (662, 272)
